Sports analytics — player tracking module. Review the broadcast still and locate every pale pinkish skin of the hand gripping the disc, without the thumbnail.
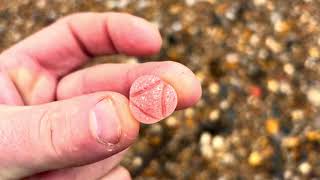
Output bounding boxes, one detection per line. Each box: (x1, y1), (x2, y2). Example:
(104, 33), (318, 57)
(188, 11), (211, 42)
(0, 13), (201, 180)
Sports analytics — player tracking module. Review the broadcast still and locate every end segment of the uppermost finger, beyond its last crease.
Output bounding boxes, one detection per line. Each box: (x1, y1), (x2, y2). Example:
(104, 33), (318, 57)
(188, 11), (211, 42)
(107, 13), (162, 56)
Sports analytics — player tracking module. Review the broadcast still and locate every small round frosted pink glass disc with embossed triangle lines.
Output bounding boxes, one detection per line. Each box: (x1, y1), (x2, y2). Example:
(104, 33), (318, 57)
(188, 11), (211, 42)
(129, 75), (178, 124)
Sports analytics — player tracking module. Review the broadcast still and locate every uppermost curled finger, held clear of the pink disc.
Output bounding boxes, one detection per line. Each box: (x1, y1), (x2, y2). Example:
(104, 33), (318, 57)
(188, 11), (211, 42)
(1, 13), (162, 77)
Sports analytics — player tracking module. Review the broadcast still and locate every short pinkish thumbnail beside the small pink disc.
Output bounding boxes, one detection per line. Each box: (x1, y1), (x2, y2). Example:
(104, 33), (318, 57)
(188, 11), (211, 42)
(90, 99), (121, 145)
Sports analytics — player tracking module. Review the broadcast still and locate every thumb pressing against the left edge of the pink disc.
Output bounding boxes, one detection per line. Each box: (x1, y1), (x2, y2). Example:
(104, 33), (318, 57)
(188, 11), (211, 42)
(0, 92), (139, 179)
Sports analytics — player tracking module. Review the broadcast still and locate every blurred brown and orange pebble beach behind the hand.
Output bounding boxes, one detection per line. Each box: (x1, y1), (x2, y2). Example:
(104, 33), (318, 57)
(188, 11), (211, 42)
(0, 0), (320, 180)
